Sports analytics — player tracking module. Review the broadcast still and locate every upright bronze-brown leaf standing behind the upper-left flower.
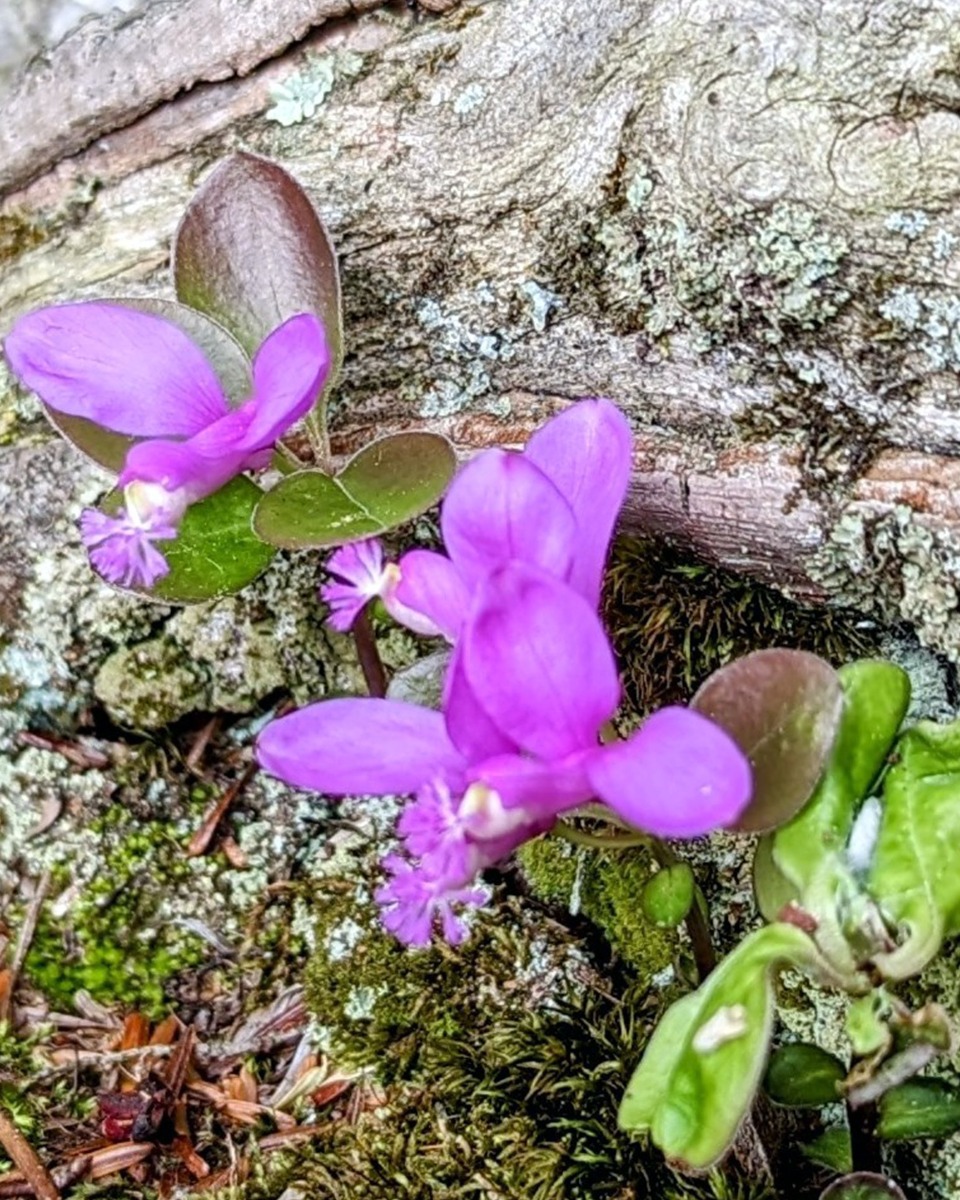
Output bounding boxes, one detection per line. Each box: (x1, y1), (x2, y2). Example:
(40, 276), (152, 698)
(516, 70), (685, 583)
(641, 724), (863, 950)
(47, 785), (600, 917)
(173, 152), (343, 446)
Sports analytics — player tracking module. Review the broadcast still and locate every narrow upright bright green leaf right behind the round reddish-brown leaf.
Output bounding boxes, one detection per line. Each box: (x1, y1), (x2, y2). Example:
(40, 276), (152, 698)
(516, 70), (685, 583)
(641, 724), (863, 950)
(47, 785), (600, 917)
(772, 659), (910, 899)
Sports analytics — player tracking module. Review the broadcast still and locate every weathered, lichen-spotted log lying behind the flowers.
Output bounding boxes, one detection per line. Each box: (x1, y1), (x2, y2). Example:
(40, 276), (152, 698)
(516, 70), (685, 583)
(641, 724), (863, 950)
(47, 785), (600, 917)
(0, 0), (960, 655)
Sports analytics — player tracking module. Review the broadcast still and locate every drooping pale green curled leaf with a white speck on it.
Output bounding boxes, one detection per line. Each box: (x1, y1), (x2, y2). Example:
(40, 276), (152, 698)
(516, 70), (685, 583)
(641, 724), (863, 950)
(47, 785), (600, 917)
(619, 924), (815, 1169)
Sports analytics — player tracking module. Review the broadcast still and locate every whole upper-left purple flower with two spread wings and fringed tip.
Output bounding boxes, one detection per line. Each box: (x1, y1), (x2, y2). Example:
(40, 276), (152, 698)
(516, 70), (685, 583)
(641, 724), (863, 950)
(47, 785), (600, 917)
(4, 301), (331, 587)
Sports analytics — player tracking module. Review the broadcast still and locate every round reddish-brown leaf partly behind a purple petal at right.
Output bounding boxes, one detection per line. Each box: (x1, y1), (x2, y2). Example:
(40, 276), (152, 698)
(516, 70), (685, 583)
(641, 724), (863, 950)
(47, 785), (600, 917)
(691, 649), (842, 833)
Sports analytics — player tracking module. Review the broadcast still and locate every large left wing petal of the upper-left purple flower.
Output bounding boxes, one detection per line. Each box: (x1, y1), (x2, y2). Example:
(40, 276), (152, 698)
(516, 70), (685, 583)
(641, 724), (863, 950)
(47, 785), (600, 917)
(4, 301), (228, 438)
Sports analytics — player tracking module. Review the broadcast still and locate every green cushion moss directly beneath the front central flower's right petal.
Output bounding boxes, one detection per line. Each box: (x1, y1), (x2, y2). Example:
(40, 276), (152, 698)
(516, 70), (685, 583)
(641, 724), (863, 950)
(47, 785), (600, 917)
(517, 838), (678, 984)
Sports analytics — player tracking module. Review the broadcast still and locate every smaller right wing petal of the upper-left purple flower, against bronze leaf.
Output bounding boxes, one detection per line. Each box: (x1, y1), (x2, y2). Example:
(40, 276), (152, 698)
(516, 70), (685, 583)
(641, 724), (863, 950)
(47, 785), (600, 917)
(235, 312), (332, 452)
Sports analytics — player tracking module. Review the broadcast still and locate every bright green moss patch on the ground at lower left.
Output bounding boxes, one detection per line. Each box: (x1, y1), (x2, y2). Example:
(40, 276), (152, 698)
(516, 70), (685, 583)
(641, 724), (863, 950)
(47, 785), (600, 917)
(25, 805), (209, 1016)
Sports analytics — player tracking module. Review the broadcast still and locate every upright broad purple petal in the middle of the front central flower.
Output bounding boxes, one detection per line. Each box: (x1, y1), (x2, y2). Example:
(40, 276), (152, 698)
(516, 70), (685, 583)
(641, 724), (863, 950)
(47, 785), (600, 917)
(463, 563), (620, 760)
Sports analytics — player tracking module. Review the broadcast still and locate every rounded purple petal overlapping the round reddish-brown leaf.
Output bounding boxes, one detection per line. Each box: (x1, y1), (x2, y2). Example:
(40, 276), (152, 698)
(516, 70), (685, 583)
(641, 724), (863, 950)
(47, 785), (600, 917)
(587, 707), (752, 838)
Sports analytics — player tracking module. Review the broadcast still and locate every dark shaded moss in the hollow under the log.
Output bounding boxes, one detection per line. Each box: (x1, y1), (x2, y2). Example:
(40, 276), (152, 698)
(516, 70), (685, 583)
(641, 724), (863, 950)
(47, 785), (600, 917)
(605, 538), (876, 714)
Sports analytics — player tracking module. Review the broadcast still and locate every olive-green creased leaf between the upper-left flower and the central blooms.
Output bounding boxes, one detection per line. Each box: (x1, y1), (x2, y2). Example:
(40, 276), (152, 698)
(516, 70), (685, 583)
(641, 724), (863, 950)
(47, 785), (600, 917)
(253, 432), (456, 550)
